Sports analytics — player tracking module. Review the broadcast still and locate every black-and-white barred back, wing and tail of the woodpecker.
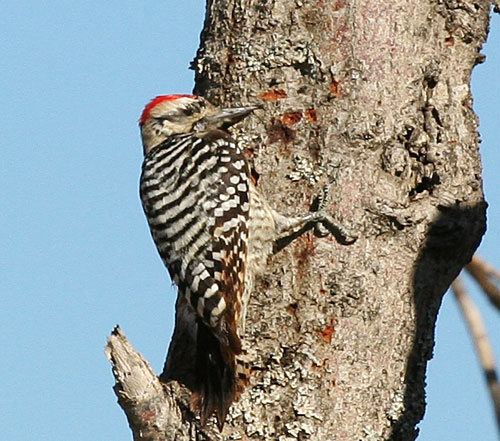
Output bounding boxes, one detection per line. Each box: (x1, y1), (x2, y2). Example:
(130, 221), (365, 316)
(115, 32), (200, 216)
(140, 126), (251, 426)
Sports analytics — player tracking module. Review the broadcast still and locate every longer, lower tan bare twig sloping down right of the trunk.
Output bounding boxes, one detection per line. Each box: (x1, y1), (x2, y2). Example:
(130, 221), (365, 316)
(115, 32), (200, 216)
(451, 277), (500, 432)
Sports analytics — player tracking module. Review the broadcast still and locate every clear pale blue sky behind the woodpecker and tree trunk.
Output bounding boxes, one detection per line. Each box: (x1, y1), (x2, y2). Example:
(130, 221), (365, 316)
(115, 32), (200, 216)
(0, 0), (500, 441)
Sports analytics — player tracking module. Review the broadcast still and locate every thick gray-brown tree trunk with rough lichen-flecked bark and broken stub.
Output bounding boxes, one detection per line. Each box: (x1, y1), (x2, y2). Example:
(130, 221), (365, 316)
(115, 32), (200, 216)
(108, 0), (490, 441)
